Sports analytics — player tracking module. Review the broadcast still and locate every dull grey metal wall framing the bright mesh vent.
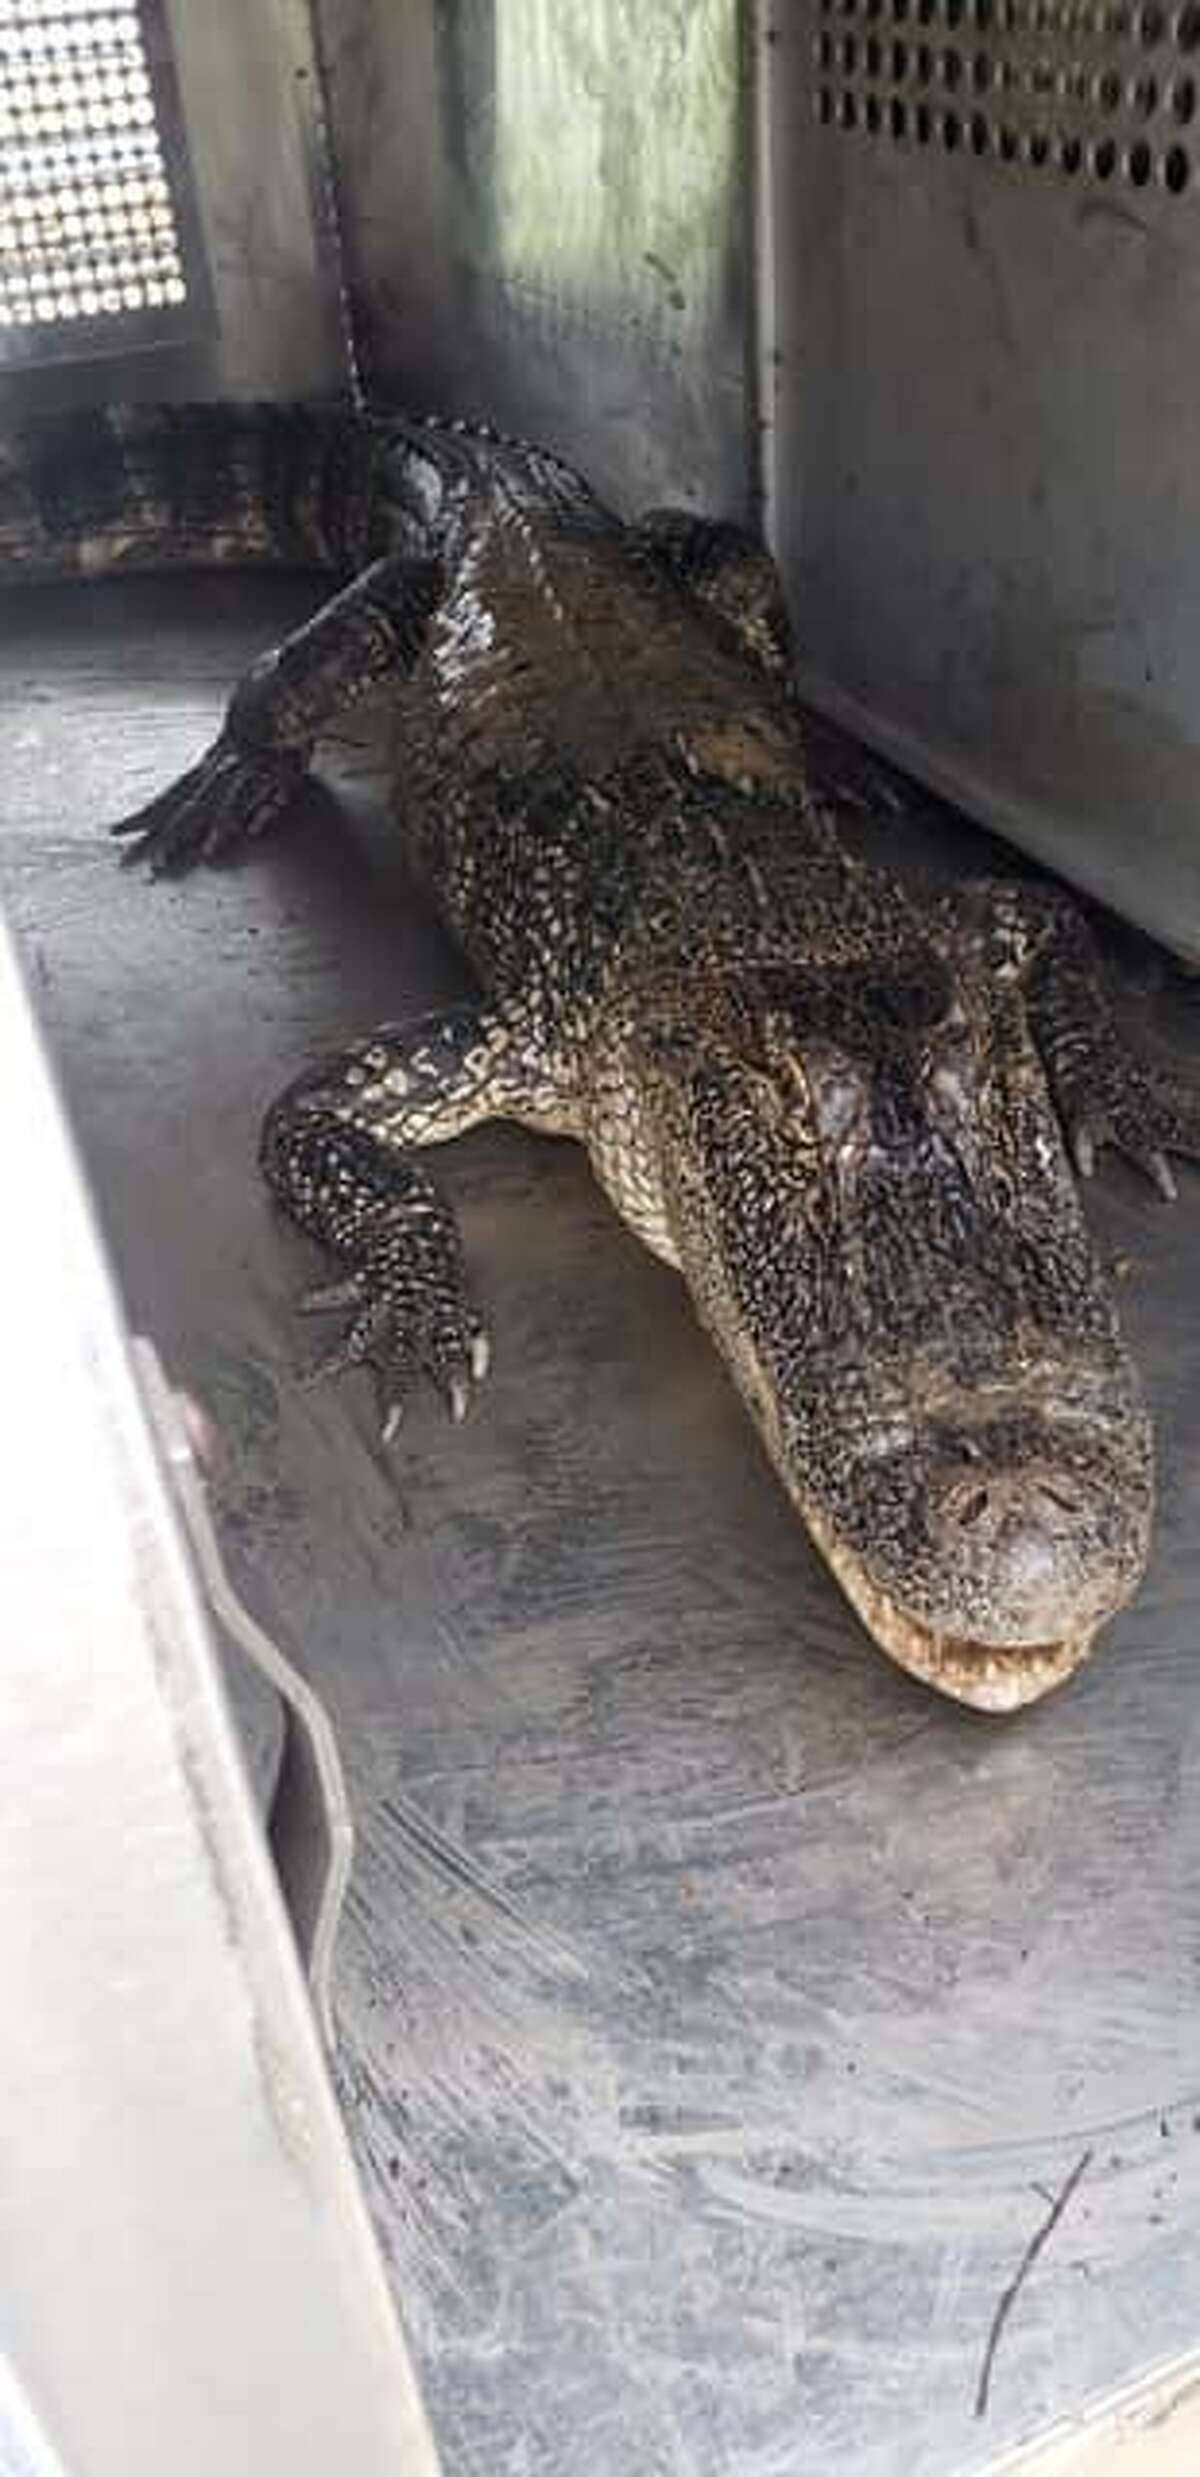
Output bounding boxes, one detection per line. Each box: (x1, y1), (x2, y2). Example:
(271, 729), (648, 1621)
(0, 0), (347, 414)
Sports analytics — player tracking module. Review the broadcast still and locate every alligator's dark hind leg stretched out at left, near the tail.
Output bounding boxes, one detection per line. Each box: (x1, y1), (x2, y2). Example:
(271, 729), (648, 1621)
(112, 560), (441, 877)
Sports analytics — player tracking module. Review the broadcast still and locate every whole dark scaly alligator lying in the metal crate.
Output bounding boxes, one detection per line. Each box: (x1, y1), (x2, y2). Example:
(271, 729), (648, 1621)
(0, 406), (1200, 1712)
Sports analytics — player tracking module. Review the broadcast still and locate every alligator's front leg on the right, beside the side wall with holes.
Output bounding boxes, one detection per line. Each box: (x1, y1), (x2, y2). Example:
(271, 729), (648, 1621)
(957, 884), (1200, 1201)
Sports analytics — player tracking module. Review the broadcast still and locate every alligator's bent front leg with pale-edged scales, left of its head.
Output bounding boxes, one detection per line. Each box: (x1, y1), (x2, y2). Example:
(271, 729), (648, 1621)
(260, 1006), (568, 1444)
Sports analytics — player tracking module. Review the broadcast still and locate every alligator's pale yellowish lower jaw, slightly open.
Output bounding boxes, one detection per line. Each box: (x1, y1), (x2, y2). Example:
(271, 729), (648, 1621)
(803, 1506), (1101, 1712)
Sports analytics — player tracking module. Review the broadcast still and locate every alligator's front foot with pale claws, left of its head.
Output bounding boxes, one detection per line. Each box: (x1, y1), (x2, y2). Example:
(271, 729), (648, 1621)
(298, 1239), (491, 1444)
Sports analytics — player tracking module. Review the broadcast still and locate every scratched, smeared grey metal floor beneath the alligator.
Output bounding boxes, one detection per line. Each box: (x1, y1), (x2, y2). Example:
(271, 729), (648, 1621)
(0, 580), (1200, 2477)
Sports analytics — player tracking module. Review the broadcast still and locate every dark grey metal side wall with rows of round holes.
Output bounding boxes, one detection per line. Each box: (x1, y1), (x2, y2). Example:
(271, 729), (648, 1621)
(769, 0), (1200, 961)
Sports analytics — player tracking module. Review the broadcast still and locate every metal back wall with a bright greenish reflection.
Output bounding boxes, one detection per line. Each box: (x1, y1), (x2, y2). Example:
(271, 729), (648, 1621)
(317, 0), (751, 513)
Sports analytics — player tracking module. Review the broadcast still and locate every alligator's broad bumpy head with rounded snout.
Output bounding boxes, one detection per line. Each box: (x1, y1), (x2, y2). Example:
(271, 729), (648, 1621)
(660, 934), (1153, 1712)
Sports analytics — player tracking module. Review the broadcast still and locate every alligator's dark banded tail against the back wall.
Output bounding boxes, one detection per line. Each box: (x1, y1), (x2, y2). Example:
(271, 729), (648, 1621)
(0, 404), (374, 587)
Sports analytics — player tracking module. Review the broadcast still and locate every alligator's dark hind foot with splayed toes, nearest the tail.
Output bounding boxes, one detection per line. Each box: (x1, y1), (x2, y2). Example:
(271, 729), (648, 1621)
(109, 736), (305, 877)
